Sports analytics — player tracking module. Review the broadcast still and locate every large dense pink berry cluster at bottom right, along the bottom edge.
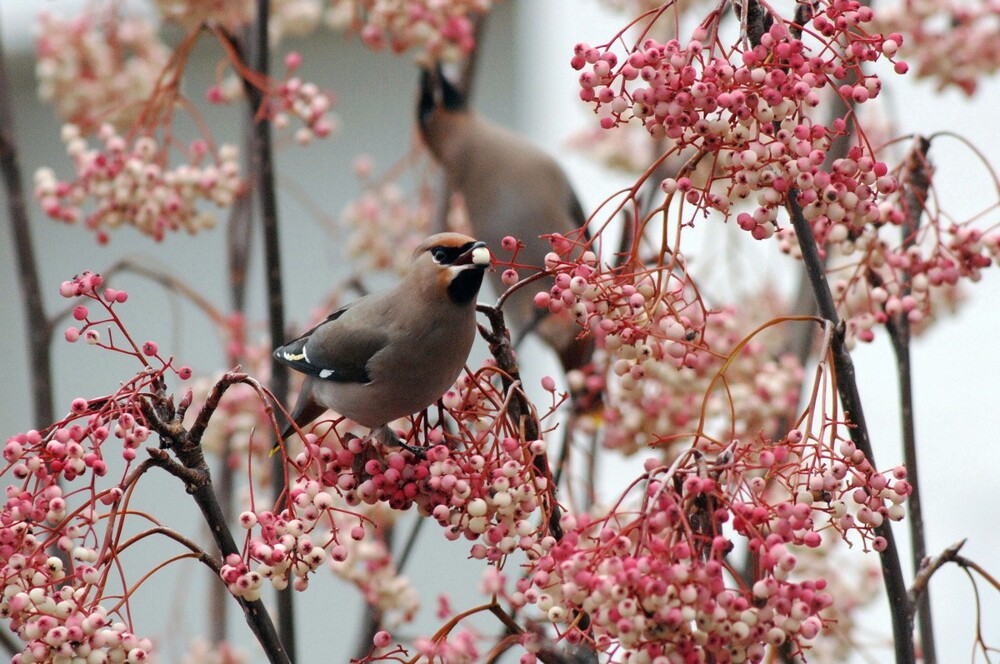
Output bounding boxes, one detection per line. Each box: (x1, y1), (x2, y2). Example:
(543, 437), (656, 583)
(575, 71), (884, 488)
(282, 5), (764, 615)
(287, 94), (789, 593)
(509, 430), (910, 662)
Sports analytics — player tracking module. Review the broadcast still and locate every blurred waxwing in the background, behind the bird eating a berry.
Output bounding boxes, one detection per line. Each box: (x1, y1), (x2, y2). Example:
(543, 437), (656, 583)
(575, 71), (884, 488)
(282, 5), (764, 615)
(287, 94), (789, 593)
(417, 67), (593, 370)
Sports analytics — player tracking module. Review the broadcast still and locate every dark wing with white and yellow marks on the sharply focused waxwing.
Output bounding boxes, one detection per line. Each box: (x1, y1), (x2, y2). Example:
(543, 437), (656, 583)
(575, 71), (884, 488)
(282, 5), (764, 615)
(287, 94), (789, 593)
(274, 306), (389, 383)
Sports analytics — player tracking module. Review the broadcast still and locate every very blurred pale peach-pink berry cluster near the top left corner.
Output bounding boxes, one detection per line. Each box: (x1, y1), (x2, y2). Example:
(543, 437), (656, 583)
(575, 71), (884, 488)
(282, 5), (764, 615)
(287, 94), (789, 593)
(35, 11), (170, 132)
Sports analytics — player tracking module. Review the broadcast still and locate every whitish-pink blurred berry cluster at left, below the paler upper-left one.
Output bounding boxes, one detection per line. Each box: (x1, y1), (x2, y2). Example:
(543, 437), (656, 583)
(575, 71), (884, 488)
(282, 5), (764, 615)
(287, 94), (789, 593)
(35, 125), (243, 242)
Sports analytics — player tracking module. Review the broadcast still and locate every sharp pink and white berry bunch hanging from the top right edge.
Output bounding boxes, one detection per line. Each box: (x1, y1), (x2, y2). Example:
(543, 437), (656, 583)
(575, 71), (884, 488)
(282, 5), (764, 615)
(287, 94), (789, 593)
(572, 0), (905, 239)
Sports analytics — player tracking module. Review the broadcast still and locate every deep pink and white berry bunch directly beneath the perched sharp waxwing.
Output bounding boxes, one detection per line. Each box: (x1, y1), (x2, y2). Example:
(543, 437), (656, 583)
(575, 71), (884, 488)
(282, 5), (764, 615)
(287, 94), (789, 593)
(282, 378), (553, 561)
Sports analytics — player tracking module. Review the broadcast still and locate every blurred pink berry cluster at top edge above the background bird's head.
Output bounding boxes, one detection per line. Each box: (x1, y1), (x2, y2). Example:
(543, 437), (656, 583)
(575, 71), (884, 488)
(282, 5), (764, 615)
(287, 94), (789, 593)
(330, 0), (493, 64)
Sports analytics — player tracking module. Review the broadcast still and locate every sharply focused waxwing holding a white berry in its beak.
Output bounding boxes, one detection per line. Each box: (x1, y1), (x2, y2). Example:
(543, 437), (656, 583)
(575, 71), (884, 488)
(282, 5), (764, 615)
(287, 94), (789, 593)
(274, 233), (490, 443)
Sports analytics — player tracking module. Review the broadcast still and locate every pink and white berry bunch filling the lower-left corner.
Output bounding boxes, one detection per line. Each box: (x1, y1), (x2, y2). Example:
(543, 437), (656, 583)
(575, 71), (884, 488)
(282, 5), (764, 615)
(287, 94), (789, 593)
(0, 272), (191, 664)
